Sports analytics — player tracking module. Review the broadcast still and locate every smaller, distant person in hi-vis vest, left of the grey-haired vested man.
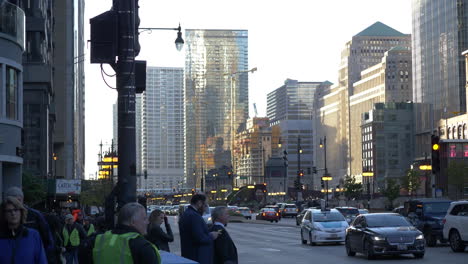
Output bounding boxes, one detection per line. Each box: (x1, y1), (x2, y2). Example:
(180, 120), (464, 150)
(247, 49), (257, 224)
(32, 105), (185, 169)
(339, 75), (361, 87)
(62, 214), (86, 264)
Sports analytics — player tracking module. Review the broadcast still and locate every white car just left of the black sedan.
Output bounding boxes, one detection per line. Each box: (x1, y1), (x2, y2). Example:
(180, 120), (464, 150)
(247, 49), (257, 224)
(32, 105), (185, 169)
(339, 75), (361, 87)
(301, 209), (349, 245)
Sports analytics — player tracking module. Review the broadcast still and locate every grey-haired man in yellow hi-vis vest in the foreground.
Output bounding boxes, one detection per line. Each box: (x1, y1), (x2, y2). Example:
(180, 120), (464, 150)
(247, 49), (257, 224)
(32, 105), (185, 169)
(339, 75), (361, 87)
(80, 203), (161, 264)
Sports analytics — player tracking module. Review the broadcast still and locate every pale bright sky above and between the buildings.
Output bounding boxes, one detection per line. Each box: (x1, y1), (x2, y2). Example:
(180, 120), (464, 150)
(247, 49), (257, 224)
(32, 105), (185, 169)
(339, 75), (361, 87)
(84, 0), (411, 178)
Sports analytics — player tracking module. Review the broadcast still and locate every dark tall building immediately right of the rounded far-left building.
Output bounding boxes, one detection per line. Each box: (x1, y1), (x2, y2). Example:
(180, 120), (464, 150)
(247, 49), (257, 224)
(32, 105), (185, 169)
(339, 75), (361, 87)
(19, 0), (54, 178)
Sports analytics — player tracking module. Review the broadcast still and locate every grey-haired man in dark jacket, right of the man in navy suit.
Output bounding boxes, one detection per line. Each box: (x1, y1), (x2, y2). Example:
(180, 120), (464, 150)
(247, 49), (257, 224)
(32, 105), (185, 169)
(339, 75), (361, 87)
(210, 206), (238, 264)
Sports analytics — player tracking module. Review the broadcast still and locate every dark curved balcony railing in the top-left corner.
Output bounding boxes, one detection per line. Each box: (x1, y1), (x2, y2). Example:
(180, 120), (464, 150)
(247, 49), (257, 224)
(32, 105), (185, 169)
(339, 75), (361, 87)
(0, 0), (25, 50)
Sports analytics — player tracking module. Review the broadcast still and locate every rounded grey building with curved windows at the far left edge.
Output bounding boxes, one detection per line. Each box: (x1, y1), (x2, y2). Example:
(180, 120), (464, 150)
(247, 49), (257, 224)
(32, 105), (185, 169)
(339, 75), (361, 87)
(0, 1), (25, 198)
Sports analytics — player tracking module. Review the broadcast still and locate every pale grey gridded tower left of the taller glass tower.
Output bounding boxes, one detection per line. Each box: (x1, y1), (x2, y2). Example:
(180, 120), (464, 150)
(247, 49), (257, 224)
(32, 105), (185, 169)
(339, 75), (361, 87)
(137, 67), (184, 190)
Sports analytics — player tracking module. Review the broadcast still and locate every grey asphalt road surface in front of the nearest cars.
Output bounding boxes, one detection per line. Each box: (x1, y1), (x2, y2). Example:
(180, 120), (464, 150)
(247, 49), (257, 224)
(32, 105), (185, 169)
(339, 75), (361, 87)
(169, 217), (468, 264)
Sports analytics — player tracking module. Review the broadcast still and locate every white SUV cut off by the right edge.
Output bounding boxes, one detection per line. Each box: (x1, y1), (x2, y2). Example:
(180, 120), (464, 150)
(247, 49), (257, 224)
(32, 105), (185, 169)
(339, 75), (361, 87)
(442, 201), (468, 252)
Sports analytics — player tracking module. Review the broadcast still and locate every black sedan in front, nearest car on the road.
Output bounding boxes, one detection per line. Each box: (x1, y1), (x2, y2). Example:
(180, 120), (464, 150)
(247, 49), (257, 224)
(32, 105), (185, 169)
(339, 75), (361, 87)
(345, 213), (425, 259)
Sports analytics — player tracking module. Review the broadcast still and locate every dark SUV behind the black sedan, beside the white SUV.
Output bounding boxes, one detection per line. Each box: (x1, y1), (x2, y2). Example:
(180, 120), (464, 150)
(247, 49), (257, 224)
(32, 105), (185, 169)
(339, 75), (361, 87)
(402, 198), (451, 247)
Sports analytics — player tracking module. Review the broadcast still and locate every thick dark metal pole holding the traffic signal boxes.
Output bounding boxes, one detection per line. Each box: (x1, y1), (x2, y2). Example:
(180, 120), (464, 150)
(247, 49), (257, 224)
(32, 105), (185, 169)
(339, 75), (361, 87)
(116, 0), (138, 208)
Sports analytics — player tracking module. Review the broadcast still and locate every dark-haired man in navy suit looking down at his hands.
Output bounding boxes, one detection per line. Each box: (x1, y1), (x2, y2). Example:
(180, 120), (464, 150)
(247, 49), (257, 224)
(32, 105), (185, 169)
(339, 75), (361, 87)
(179, 194), (218, 264)
